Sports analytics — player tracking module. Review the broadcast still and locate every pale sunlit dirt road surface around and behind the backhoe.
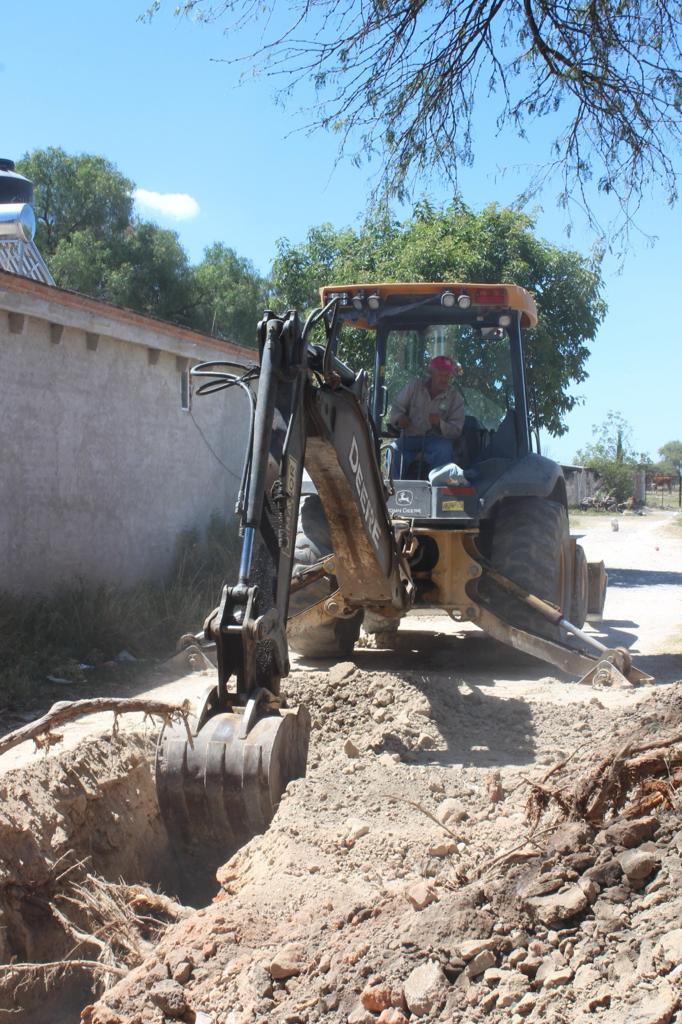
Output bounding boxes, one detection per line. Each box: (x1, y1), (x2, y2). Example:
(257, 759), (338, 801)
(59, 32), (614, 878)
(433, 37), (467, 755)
(0, 512), (682, 772)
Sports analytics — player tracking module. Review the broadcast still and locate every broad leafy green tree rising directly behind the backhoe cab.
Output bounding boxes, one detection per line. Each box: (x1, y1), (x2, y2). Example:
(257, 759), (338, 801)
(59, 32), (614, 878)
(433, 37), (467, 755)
(272, 201), (606, 434)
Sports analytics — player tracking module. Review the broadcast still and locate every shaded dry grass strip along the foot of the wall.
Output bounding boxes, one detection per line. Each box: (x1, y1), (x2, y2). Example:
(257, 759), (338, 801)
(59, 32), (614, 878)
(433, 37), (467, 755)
(0, 517), (239, 710)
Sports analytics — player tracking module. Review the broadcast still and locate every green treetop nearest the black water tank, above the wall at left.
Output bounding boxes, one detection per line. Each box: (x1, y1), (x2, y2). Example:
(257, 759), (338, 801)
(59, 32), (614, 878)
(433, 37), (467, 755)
(16, 146), (134, 260)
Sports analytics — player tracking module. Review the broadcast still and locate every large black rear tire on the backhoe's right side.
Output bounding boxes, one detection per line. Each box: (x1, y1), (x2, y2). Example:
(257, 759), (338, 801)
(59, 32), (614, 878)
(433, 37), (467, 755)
(484, 498), (571, 638)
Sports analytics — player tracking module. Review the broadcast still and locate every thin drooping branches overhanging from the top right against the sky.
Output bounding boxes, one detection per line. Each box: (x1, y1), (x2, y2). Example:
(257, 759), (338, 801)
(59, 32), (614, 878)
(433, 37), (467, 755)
(147, 0), (682, 238)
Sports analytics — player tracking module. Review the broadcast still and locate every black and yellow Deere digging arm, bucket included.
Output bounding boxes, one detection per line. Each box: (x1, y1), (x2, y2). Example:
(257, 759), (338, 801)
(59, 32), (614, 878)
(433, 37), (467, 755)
(157, 302), (410, 863)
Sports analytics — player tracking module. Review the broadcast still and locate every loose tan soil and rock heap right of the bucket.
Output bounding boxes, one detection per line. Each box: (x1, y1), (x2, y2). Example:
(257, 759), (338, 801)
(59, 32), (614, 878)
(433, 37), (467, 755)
(82, 663), (682, 1024)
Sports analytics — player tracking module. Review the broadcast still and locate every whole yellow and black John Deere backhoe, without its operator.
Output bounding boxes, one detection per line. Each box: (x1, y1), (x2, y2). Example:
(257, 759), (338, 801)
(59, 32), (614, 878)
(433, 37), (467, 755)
(157, 283), (643, 863)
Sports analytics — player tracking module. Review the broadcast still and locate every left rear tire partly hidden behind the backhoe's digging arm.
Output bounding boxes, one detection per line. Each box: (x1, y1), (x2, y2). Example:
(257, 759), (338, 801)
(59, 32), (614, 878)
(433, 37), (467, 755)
(289, 495), (363, 658)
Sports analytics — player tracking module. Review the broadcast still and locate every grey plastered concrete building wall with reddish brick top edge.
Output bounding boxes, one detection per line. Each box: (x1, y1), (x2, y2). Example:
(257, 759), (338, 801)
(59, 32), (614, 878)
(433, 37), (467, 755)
(0, 272), (255, 594)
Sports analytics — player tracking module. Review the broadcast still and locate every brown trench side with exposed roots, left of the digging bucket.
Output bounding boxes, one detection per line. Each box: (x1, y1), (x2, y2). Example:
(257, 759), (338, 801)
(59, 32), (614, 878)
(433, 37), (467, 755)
(0, 733), (189, 1024)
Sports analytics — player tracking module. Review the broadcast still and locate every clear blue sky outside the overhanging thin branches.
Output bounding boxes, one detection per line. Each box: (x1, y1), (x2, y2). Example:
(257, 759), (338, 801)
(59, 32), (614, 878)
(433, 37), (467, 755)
(0, 0), (682, 461)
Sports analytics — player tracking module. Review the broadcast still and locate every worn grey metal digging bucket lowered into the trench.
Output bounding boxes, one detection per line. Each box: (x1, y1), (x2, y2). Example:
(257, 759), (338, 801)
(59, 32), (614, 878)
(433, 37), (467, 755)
(156, 689), (310, 868)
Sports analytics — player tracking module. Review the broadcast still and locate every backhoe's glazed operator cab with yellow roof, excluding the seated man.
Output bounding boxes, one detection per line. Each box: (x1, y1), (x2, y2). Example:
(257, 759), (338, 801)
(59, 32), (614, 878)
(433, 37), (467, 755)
(321, 283), (537, 525)
